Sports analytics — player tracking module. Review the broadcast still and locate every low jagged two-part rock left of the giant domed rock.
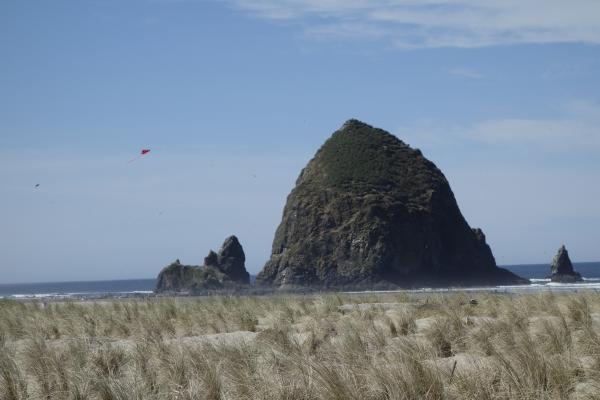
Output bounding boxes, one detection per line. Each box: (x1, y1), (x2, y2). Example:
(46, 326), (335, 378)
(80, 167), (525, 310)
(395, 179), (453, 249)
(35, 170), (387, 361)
(155, 236), (250, 293)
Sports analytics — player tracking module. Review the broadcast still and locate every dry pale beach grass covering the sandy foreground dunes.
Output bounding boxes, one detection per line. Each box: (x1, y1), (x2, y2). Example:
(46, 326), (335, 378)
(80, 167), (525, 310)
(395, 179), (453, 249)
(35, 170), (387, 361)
(0, 293), (600, 400)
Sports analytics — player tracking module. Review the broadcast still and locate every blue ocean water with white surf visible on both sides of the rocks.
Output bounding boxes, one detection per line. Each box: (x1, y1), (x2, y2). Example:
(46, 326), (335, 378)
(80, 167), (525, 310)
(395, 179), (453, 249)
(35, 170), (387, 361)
(0, 262), (600, 299)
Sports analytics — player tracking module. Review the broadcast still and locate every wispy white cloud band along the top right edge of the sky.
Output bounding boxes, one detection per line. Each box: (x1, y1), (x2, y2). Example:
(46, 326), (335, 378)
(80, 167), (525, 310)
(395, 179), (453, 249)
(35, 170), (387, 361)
(226, 0), (600, 49)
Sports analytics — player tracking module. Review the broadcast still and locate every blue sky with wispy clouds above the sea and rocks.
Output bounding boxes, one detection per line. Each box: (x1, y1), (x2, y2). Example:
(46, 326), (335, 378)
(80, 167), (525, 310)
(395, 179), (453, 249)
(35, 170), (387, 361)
(0, 0), (600, 283)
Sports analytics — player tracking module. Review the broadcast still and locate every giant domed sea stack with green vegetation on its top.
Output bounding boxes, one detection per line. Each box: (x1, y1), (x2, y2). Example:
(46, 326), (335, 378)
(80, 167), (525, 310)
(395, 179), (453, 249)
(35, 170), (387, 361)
(257, 120), (527, 288)
